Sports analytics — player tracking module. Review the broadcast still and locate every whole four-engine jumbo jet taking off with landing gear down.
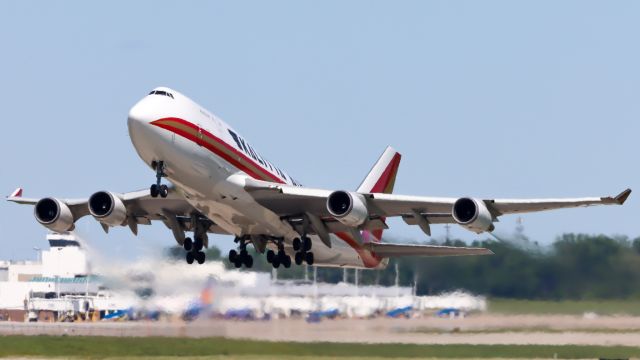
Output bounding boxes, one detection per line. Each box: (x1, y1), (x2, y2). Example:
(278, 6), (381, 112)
(8, 87), (631, 269)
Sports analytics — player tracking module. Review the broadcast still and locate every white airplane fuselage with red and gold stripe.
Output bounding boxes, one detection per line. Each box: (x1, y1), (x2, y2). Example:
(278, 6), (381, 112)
(128, 88), (386, 268)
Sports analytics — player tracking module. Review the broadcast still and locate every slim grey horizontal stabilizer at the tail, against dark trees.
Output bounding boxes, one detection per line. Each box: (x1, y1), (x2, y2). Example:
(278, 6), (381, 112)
(365, 243), (493, 257)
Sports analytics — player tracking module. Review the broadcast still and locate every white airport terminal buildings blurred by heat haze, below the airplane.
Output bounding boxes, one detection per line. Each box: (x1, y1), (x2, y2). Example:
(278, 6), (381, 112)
(0, 233), (486, 322)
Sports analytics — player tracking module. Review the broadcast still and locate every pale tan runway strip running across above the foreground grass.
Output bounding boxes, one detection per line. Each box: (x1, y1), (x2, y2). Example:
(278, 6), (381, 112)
(0, 315), (640, 346)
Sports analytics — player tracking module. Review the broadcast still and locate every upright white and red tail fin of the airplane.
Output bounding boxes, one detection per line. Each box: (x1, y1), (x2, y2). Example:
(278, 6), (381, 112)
(357, 146), (402, 242)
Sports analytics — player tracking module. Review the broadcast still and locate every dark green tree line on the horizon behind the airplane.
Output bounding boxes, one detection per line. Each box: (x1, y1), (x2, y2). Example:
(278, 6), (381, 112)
(167, 234), (640, 300)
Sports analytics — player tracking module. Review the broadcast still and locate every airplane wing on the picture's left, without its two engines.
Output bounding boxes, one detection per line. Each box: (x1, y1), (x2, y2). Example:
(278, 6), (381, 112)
(7, 187), (228, 234)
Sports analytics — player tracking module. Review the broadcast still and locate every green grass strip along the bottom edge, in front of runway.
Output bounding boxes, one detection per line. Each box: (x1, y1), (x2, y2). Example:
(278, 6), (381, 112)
(0, 336), (640, 359)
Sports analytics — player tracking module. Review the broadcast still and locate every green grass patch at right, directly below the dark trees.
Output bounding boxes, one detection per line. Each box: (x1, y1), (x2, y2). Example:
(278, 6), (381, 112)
(488, 299), (640, 316)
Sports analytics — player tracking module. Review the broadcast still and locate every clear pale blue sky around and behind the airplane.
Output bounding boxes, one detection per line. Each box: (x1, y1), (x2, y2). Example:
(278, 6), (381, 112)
(0, 1), (640, 259)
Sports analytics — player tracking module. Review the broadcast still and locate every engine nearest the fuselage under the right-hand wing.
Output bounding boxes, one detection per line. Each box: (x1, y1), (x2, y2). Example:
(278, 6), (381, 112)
(327, 190), (369, 227)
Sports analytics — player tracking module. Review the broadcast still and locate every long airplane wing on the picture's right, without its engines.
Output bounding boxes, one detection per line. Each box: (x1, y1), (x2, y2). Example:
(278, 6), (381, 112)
(245, 180), (631, 234)
